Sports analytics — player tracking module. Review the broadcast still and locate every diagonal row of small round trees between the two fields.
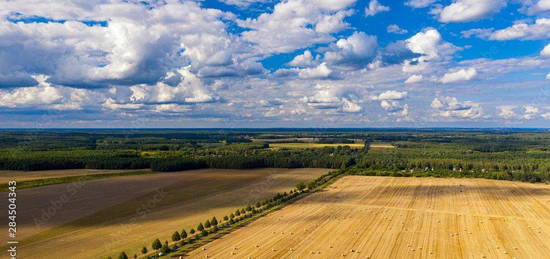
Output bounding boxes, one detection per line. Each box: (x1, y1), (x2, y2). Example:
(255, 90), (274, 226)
(108, 170), (344, 259)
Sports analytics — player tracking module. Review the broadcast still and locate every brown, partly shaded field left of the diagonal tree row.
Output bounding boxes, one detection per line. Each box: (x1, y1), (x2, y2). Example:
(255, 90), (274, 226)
(5, 169), (329, 258)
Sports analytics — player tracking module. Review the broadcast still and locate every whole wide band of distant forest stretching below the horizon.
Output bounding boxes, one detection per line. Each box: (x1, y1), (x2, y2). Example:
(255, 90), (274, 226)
(0, 129), (550, 182)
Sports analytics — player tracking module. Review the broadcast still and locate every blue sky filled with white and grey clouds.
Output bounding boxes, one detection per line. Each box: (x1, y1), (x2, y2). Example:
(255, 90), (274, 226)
(0, 0), (550, 128)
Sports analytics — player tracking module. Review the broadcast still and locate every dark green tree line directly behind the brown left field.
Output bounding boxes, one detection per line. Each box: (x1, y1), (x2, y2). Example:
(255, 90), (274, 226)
(0, 146), (360, 172)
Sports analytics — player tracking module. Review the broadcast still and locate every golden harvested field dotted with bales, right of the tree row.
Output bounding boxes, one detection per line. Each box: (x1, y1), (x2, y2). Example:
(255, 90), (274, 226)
(189, 176), (550, 258)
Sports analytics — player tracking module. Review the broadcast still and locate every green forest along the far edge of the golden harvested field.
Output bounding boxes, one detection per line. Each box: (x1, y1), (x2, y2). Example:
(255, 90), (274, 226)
(354, 143), (550, 182)
